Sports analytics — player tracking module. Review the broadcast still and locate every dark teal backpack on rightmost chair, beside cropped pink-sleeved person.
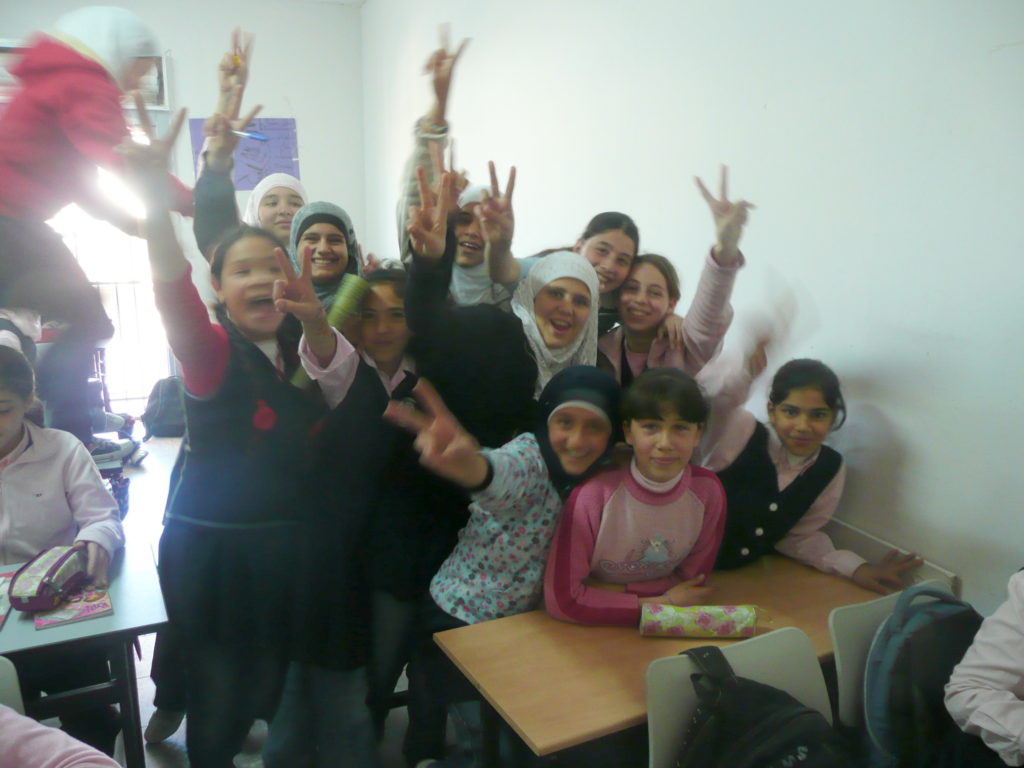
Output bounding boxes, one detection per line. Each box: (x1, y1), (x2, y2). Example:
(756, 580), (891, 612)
(864, 587), (982, 768)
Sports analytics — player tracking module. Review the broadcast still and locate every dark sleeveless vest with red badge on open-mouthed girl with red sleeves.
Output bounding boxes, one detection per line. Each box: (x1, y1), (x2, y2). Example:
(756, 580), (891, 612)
(167, 316), (322, 527)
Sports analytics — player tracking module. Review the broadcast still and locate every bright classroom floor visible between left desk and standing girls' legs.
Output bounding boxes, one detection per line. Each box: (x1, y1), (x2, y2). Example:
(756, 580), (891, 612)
(116, 436), (406, 768)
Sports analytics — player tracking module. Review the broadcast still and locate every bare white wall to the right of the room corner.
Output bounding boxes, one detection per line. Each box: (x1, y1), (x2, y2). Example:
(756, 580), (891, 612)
(361, 0), (1024, 609)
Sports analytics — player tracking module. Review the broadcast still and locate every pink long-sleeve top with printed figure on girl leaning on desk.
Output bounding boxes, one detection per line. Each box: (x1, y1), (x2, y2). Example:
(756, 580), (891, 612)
(544, 464), (725, 625)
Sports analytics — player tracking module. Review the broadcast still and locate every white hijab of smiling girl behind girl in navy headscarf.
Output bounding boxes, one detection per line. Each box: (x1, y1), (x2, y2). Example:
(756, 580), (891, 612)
(512, 251), (599, 394)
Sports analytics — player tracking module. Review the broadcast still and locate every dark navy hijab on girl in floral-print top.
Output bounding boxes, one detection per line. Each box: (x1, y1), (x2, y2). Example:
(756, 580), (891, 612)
(534, 366), (622, 499)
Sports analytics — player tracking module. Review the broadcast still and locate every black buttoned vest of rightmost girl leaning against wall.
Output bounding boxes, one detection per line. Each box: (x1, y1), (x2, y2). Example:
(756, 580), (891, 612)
(715, 422), (843, 569)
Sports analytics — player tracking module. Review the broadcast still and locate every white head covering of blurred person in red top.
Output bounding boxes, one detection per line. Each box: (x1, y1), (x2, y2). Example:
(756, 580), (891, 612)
(53, 5), (160, 88)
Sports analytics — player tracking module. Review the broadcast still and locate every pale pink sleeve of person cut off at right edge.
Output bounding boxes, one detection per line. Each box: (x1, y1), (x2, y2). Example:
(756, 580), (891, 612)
(946, 572), (1024, 765)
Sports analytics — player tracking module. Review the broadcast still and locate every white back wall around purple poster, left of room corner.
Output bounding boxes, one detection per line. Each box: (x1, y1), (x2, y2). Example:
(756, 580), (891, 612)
(0, 0), (365, 230)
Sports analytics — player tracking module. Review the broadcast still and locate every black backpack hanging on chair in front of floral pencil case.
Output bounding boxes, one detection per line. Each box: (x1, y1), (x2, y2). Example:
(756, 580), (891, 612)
(676, 645), (852, 768)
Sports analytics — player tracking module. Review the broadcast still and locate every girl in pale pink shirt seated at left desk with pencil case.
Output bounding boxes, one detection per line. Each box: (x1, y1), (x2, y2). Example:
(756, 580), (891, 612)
(0, 346), (124, 754)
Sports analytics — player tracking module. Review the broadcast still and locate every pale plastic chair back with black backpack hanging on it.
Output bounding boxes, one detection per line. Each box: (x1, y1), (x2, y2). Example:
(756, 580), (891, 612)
(646, 627), (831, 768)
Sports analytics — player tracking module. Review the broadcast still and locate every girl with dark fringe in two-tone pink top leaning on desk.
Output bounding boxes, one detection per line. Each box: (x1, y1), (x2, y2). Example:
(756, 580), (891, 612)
(544, 368), (725, 625)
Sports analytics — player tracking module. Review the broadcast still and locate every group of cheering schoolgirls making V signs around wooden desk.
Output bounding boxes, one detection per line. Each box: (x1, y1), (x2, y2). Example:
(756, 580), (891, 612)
(0, 12), (929, 768)
